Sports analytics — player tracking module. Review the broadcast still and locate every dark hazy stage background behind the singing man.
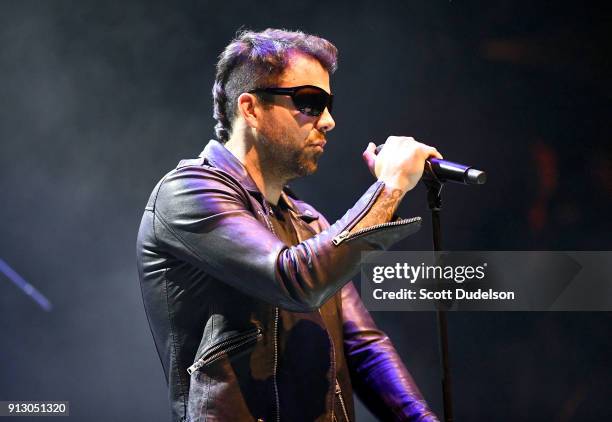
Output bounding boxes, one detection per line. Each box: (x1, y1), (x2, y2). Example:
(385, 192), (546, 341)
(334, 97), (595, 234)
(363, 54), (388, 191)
(0, 0), (612, 421)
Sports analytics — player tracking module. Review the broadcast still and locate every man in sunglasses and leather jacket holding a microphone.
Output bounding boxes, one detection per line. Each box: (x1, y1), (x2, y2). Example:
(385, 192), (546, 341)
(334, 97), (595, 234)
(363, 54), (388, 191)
(138, 29), (440, 422)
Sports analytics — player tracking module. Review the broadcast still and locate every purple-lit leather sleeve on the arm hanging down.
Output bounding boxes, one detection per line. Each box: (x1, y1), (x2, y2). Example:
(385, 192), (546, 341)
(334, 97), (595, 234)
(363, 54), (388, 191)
(342, 283), (438, 422)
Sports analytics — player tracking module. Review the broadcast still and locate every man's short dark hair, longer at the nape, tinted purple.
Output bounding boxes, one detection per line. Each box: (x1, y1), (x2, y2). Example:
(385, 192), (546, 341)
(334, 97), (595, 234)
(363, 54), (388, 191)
(212, 28), (338, 143)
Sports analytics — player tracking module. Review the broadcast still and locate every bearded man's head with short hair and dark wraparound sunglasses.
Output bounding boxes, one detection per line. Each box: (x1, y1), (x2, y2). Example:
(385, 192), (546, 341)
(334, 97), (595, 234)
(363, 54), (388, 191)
(213, 29), (337, 178)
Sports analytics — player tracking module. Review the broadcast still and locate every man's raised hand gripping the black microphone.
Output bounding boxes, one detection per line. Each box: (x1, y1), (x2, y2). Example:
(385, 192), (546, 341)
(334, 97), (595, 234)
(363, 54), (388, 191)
(363, 136), (442, 196)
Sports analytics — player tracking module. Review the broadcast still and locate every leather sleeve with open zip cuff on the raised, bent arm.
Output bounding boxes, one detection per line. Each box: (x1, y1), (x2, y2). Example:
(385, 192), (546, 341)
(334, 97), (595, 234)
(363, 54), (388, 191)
(153, 166), (420, 312)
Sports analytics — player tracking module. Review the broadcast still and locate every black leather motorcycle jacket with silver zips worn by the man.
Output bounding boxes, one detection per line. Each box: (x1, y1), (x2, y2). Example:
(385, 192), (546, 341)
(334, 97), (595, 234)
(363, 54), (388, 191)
(137, 141), (437, 422)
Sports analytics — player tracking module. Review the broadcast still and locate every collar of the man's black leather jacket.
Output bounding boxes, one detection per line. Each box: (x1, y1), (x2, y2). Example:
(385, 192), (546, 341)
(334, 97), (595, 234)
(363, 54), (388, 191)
(200, 139), (299, 212)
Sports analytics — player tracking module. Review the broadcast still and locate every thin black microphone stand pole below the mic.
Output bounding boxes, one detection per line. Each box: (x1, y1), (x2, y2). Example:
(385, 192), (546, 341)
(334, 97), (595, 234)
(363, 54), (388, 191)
(422, 172), (453, 422)
